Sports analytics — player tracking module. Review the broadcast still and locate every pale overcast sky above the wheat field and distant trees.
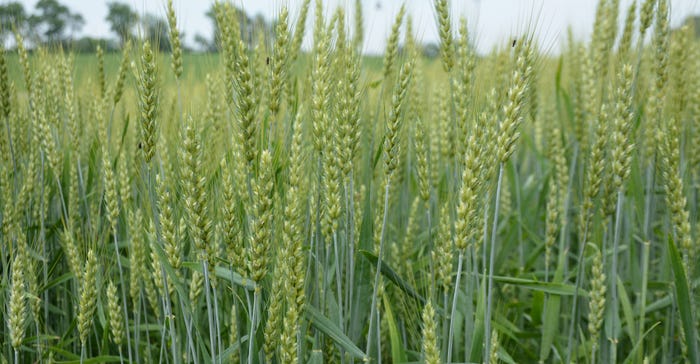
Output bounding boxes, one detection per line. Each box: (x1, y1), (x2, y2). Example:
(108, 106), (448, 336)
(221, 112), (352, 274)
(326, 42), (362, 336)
(12, 0), (700, 53)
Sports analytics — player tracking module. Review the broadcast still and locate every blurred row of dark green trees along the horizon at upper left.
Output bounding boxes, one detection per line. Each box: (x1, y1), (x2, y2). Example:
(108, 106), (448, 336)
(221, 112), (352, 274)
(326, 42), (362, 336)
(0, 0), (275, 52)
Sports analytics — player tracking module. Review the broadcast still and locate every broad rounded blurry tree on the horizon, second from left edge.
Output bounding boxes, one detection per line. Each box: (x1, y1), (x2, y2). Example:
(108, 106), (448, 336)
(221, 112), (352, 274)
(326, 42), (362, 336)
(29, 0), (85, 43)
